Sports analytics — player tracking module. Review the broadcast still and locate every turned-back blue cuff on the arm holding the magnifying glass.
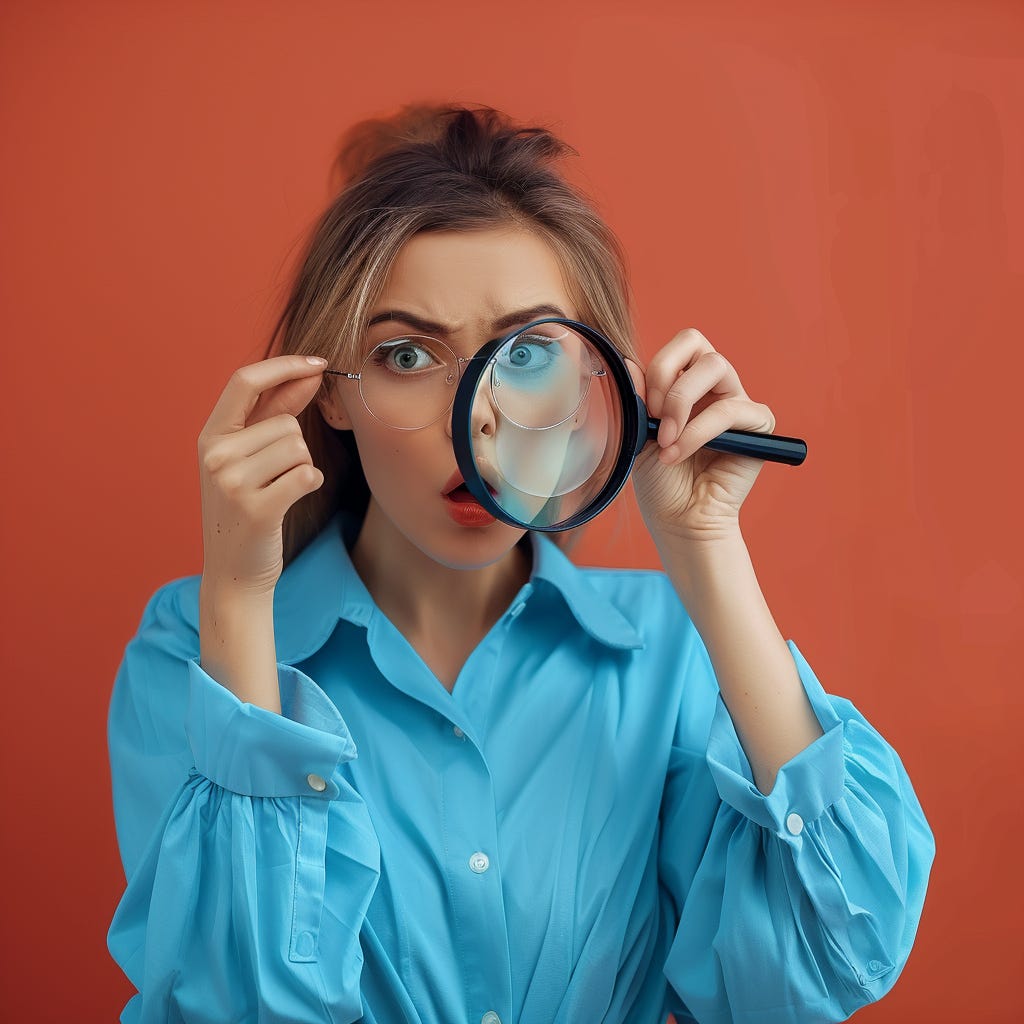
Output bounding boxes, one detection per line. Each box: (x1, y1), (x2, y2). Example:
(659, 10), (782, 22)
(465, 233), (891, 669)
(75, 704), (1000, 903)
(708, 640), (846, 839)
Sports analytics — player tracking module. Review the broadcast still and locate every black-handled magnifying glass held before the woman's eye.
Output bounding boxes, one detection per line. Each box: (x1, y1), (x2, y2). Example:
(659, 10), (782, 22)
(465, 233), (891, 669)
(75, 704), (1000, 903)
(452, 317), (807, 532)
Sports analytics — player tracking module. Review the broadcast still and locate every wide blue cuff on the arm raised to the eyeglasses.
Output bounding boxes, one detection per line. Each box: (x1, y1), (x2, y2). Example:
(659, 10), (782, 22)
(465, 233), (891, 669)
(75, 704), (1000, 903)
(185, 657), (357, 800)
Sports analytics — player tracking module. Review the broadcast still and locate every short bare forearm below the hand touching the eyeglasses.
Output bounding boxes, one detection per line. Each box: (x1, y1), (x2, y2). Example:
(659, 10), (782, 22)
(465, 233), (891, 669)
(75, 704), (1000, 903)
(199, 584), (281, 715)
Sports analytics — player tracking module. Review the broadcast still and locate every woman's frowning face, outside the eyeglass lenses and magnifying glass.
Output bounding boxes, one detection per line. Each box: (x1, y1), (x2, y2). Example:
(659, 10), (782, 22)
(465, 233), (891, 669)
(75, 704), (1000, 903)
(322, 226), (579, 568)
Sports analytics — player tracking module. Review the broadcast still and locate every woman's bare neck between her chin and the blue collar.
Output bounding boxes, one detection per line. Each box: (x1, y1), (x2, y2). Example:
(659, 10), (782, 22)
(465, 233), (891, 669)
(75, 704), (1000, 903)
(352, 498), (531, 640)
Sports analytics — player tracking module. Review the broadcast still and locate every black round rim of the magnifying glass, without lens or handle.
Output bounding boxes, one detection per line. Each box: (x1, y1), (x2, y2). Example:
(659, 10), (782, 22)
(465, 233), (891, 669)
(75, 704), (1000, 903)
(452, 316), (647, 534)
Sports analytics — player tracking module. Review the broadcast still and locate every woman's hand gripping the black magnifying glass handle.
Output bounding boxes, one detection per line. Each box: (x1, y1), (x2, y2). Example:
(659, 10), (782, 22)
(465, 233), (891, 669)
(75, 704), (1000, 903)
(630, 328), (775, 541)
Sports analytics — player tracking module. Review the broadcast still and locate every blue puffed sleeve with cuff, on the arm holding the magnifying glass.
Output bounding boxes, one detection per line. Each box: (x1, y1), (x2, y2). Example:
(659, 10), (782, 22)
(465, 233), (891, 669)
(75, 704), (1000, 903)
(658, 640), (935, 1024)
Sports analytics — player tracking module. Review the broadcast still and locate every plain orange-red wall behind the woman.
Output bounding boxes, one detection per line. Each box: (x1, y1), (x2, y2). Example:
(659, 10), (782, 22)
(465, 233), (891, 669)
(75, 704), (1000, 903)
(0, 0), (1024, 1024)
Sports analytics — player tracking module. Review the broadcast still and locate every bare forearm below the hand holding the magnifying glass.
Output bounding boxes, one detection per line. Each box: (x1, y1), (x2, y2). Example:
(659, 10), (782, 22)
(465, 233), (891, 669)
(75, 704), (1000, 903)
(657, 527), (822, 793)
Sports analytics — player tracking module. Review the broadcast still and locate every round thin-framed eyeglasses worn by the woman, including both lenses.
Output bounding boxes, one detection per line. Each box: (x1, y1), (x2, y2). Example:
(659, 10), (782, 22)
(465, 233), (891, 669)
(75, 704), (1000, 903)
(325, 321), (603, 430)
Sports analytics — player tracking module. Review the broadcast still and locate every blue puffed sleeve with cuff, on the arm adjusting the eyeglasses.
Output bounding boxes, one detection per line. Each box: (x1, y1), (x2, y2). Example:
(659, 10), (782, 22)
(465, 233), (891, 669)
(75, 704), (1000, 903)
(108, 584), (380, 1024)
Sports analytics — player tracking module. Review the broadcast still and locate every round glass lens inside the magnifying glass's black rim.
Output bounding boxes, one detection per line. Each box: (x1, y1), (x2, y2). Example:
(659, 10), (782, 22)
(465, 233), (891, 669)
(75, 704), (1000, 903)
(472, 323), (623, 528)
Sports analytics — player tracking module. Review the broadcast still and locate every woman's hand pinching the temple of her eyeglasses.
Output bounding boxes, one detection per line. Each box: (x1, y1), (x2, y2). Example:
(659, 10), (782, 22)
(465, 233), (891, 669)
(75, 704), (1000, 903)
(199, 355), (327, 597)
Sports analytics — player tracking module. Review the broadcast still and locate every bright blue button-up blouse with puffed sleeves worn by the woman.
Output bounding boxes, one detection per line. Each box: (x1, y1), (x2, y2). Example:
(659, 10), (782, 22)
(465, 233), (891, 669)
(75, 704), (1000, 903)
(108, 516), (934, 1024)
